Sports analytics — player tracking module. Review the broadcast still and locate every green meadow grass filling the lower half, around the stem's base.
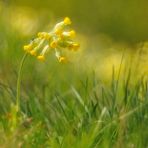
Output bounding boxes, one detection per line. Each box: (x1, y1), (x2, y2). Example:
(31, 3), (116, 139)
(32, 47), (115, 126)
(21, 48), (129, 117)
(0, 59), (148, 148)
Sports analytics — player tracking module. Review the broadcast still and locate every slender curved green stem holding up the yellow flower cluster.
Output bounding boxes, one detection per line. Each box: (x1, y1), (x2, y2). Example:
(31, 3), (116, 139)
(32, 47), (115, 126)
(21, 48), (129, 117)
(16, 52), (28, 112)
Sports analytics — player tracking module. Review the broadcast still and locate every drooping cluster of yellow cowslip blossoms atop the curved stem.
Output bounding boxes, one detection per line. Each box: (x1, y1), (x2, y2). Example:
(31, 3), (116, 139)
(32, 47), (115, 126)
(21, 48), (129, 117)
(24, 17), (79, 62)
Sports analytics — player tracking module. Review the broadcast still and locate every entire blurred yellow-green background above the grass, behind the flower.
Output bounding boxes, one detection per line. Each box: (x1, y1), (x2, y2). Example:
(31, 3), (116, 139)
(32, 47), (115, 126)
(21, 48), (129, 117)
(0, 0), (148, 85)
